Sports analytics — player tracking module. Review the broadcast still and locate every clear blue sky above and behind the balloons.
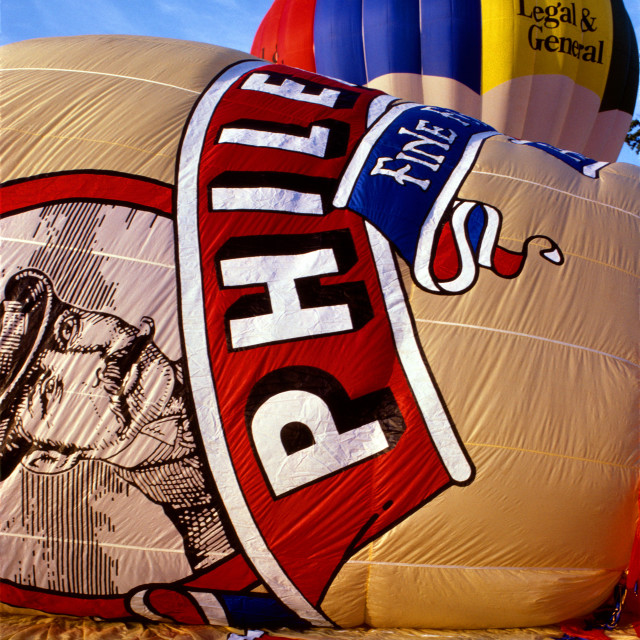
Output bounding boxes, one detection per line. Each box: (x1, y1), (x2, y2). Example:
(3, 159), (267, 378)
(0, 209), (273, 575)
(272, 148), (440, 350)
(0, 0), (640, 166)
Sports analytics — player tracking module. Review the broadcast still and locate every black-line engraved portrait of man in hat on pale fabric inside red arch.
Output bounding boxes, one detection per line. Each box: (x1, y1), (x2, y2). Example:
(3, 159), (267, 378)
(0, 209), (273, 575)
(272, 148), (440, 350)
(0, 203), (231, 594)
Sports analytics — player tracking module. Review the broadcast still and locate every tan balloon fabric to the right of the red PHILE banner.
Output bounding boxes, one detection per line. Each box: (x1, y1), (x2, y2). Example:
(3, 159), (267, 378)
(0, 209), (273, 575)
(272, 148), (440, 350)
(325, 138), (639, 627)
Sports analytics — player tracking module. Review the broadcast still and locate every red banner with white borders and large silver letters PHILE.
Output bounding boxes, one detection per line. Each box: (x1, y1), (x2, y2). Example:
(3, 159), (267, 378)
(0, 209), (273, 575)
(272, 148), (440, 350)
(177, 62), (473, 623)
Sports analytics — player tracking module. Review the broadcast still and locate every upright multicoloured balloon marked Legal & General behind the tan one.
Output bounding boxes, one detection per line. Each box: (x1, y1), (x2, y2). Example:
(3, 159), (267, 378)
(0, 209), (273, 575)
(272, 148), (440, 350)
(252, 0), (638, 160)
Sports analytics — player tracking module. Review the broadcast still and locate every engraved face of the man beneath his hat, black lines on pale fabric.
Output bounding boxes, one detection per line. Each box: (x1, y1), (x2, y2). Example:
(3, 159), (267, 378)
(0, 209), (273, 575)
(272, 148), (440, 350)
(5, 274), (184, 472)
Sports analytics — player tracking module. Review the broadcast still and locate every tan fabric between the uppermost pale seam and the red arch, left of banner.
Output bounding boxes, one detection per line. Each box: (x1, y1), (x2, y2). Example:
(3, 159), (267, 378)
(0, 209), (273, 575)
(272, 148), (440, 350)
(2, 70), (190, 182)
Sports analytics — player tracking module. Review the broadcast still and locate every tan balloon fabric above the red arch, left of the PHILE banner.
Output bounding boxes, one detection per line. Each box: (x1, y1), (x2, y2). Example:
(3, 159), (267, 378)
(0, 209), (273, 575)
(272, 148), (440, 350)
(0, 36), (254, 183)
